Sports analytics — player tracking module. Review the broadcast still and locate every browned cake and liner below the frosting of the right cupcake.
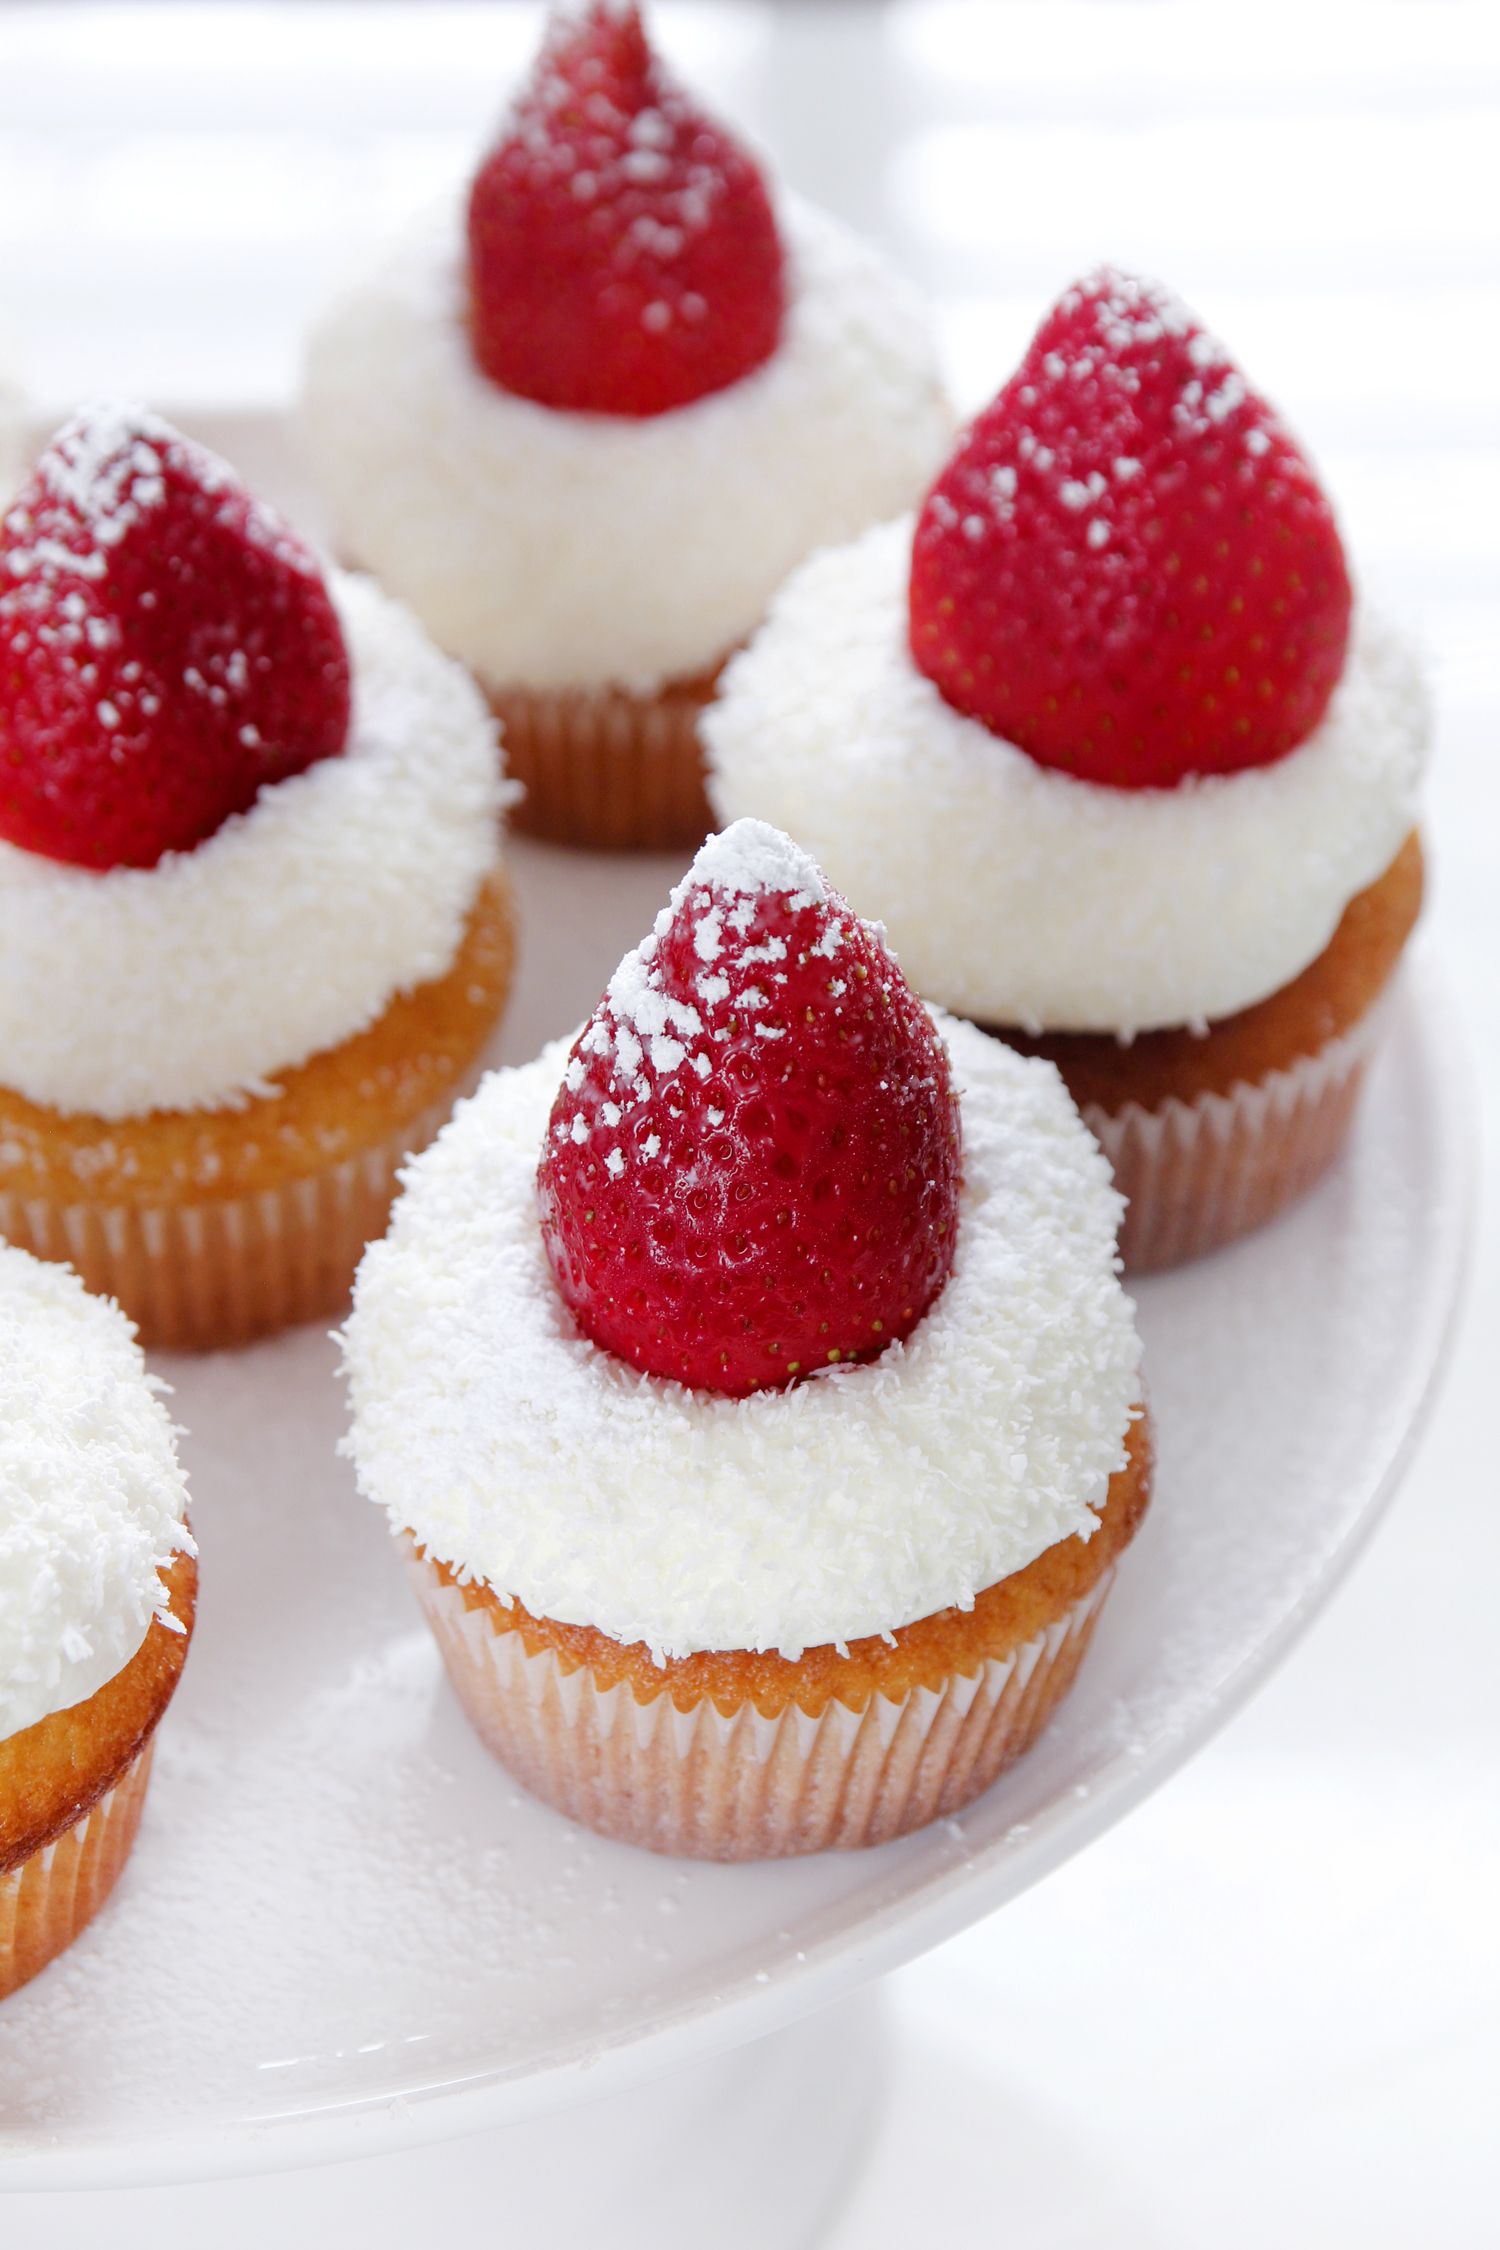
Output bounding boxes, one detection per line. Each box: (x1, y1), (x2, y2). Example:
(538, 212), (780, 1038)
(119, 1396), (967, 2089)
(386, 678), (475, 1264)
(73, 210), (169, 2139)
(983, 833), (1424, 1274)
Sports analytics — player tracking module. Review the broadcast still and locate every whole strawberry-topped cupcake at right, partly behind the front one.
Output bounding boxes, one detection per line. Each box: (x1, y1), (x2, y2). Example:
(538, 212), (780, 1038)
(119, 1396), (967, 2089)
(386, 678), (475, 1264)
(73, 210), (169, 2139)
(706, 272), (1428, 1271)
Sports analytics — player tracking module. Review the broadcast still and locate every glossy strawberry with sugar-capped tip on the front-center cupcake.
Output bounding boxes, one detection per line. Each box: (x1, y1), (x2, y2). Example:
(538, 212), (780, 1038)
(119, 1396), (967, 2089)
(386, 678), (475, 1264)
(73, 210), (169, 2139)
(537, 821), (958, 1397)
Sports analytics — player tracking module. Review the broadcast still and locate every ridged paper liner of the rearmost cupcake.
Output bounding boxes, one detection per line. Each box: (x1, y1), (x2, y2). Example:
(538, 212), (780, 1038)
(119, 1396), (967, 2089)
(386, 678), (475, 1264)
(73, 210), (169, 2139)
(486, 675), (715, 851)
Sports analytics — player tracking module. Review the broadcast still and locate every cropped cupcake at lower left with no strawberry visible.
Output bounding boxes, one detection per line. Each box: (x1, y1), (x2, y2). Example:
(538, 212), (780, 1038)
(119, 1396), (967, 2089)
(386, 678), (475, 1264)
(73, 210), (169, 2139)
(0, 1242), (198, 2000)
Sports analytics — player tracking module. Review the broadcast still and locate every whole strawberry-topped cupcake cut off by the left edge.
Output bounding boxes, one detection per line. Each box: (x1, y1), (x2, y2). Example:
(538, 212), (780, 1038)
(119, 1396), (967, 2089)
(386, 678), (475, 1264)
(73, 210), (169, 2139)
(0, 410), (513, 1346)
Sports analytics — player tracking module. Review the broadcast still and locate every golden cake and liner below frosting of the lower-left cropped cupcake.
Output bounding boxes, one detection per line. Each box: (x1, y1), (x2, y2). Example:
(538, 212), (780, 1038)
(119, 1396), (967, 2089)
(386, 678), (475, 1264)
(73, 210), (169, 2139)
(0, 1555), (198, 2000)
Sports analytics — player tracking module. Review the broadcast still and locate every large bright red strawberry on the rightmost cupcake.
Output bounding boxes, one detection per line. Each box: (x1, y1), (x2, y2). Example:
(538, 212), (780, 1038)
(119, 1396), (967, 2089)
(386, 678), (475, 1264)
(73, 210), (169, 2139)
(911, 270), (1349, 790)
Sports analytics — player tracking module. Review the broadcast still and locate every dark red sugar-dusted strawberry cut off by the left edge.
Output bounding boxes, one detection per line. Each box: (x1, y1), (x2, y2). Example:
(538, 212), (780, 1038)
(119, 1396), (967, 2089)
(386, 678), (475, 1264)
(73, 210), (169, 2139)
(0, 407), (349, 869)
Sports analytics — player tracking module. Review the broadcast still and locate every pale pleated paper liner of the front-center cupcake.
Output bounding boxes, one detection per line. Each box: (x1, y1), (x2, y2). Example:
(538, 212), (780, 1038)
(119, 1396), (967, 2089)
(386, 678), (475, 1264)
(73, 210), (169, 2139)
(407, 1548), (1113, 1859)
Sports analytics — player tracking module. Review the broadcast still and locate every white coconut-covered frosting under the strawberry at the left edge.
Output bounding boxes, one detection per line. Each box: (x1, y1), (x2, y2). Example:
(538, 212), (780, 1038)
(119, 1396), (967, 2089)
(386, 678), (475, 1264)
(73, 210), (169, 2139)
(0, 574), (504, 1118)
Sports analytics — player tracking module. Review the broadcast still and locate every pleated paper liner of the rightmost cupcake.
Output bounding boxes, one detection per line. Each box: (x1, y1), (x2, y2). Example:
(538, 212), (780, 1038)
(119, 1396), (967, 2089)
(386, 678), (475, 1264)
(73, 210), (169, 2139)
(1084, 1008), (1381, 1274)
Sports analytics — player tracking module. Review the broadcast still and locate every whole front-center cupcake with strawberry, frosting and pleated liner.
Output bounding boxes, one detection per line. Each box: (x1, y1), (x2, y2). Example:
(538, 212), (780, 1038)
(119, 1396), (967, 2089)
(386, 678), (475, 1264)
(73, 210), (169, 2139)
(344, 821), (1149, 1859)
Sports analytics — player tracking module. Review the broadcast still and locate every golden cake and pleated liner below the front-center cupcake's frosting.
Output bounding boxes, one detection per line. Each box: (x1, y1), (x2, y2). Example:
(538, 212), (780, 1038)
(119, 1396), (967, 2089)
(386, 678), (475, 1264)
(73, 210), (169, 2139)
(398, 1420), (1151, 1861)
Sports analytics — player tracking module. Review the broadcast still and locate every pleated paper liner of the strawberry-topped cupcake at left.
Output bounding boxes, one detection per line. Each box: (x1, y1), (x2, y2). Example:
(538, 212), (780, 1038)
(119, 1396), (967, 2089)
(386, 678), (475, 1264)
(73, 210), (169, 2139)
(0, 1071), (479, 1352)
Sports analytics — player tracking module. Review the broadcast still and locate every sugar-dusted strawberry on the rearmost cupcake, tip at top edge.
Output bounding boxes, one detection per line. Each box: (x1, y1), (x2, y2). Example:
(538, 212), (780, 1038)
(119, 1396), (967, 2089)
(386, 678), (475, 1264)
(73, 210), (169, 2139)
(468, 0), (785, 416)
